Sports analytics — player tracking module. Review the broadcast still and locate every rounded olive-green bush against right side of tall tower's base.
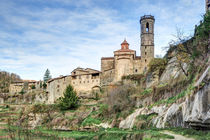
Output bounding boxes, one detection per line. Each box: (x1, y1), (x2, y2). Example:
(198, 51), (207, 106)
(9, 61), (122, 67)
(149, 58), (167, 77)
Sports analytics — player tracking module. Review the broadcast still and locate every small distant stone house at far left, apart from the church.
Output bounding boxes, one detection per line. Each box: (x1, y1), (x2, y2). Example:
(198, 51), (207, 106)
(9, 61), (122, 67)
(9, 80), (39, 94)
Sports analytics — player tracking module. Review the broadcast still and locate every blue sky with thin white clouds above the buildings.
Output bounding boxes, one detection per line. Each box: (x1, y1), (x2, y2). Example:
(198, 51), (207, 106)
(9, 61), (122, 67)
(0, 0), (205, 80)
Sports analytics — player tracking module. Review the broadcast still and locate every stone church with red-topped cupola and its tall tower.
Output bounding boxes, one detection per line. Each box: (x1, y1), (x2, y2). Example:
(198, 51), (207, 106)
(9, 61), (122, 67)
(101, 15), (155, 86)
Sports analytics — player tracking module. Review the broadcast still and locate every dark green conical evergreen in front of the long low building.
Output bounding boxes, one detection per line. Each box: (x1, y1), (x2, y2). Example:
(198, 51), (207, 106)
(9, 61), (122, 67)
(58, 85), (79, 110)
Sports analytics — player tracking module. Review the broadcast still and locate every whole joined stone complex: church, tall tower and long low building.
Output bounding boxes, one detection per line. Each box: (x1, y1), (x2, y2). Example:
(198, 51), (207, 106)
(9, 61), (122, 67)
(47, 15), (155, 103)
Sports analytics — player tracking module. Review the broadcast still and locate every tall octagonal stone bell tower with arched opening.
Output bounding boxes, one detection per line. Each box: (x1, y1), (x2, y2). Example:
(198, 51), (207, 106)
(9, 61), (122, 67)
(140, 15), (155, 69)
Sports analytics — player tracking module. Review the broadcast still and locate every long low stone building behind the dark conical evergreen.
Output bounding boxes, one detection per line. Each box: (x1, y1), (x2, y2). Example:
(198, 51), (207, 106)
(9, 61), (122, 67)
(47, 68), (100, 103)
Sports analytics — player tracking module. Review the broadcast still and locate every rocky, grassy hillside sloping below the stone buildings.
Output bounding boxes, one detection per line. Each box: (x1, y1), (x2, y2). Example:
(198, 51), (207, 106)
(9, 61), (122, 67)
(0, 12), (210, 140)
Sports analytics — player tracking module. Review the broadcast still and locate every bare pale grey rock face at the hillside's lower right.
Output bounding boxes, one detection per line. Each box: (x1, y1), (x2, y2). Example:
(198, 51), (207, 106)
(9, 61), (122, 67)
(119, 66), (210, 130)
